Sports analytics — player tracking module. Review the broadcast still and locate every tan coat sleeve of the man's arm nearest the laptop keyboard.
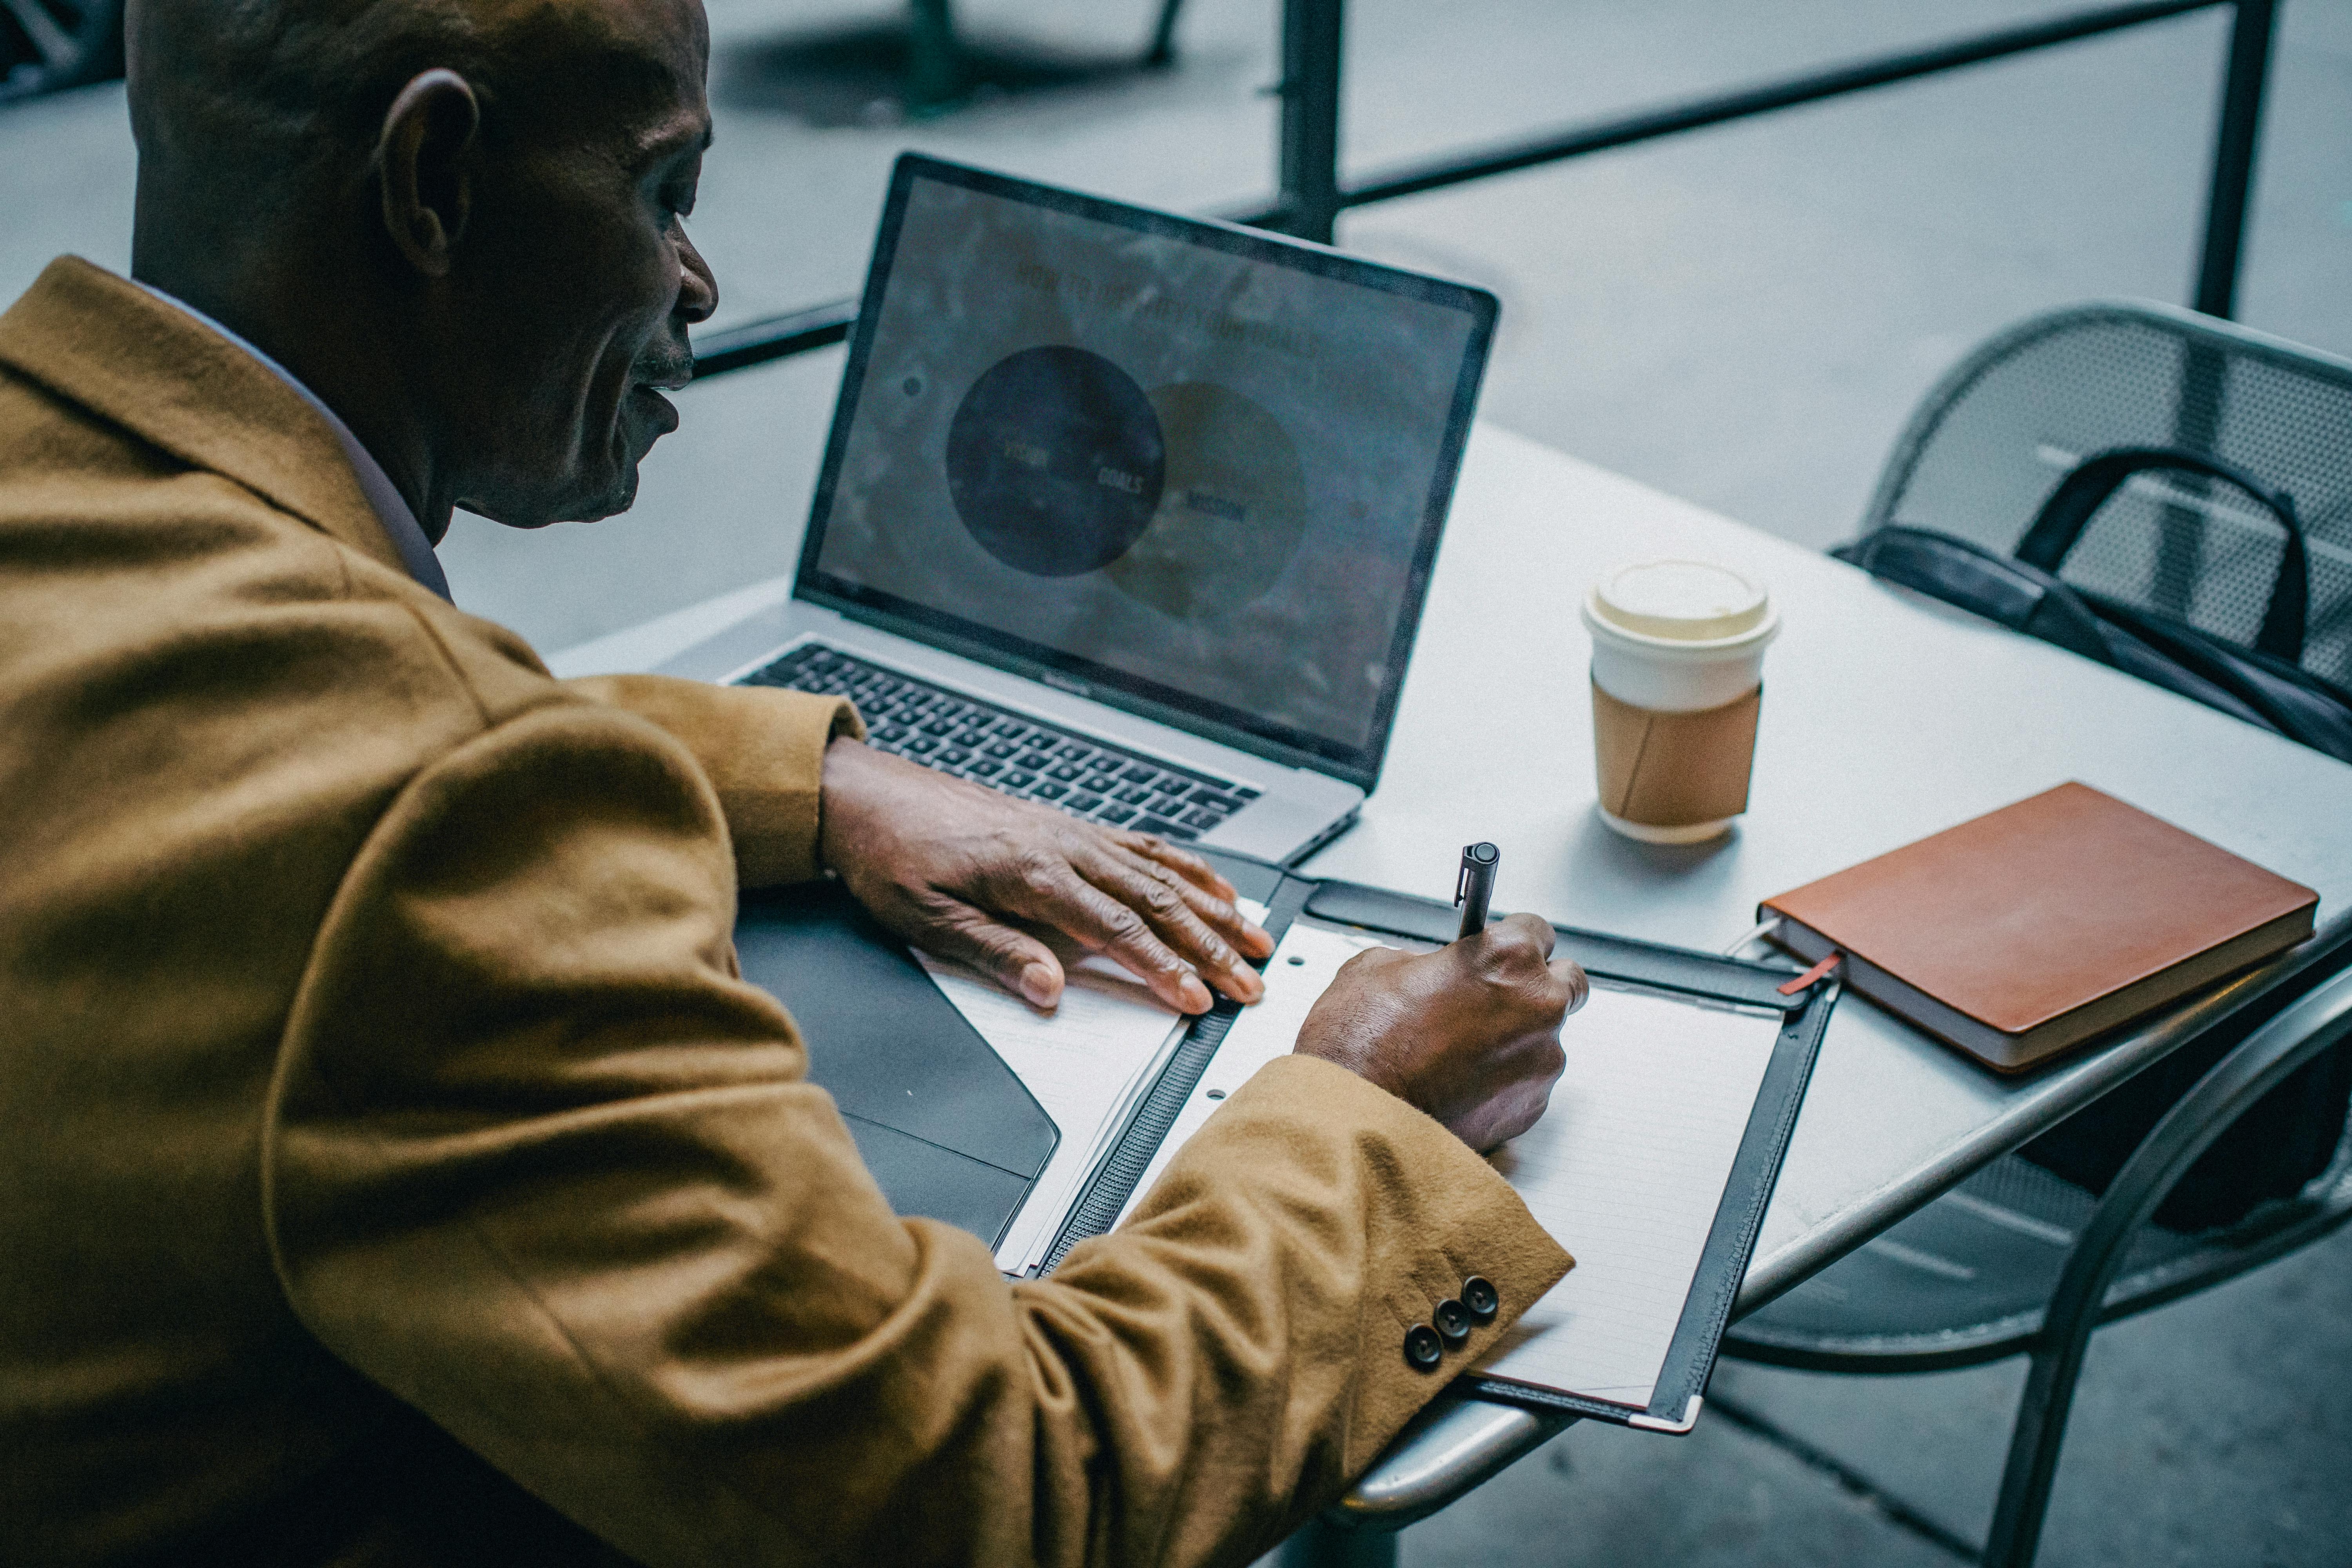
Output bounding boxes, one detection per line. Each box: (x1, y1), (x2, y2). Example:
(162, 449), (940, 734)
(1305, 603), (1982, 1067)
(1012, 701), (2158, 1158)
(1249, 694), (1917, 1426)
(564, 675), (866, 886)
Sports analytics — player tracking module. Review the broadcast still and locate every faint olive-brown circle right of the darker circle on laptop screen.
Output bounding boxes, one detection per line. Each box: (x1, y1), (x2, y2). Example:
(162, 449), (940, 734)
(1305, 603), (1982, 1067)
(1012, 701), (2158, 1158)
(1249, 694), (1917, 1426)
(1105, 381), (1308, 623)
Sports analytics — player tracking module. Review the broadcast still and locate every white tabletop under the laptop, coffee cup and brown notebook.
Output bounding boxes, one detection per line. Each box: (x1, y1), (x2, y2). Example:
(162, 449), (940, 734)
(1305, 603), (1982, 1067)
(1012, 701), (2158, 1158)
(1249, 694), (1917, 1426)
(553, 425), (2352, 1523)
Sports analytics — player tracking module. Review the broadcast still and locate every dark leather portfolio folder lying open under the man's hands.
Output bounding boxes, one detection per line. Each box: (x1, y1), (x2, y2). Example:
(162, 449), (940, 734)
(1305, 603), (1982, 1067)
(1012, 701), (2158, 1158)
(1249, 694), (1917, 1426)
(736, 853), (1837, 1432)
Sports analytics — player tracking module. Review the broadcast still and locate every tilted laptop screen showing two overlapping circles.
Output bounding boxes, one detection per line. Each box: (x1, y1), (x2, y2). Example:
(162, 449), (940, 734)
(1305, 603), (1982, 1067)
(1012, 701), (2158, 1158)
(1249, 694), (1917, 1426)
(800, 155), (1496, 788)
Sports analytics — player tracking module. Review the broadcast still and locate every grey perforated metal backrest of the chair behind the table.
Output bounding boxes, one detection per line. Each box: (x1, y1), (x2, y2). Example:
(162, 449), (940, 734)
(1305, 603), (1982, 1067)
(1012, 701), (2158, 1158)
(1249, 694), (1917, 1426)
(1863, 301), (2352, 686)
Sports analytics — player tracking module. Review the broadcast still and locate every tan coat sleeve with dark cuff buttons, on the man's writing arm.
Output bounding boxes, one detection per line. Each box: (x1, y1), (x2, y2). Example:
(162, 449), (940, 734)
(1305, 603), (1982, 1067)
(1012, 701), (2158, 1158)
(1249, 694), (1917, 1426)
(263, 703), (1569, 1568)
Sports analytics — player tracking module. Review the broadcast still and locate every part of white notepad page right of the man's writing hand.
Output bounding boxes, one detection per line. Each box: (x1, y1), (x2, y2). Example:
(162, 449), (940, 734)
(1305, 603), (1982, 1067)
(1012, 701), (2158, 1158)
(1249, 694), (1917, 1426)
(1479, 983), (1780, 1408)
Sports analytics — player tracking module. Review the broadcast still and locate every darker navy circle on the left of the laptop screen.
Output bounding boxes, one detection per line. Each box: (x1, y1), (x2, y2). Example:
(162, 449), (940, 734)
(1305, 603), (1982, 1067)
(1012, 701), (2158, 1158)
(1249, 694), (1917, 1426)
(948, 343), (1167, 576)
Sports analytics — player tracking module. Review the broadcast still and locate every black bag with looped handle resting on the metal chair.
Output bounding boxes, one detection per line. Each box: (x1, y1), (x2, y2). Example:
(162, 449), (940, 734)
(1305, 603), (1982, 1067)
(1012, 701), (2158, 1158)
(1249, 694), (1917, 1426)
(1832, 446), (2352, 1229)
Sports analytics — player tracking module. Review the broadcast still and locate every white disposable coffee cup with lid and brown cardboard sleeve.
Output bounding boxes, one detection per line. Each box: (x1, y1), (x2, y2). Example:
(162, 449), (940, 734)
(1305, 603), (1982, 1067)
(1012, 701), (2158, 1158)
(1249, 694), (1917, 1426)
(1583, 559), (1780, 844)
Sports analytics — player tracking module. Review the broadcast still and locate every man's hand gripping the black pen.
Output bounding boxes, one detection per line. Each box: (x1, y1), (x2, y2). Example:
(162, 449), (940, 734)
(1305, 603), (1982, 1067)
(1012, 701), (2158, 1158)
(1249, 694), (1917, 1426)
(1298, 915), (1590, 1152)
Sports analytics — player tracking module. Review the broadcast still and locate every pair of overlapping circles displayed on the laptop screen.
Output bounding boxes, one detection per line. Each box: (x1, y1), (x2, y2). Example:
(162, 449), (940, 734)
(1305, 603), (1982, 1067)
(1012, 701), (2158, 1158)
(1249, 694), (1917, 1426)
(948, 343), (1308, 621)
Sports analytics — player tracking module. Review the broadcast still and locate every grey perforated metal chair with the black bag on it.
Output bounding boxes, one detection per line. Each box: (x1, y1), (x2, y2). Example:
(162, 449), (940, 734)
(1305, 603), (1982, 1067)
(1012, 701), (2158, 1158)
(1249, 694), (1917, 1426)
(1724, 303), (2352, 1563)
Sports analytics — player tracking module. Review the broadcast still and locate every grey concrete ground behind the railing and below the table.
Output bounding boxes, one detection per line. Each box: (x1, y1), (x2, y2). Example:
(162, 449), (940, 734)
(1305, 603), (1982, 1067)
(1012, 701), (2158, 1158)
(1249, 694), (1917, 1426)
(0, 0), (2352, 1568)
